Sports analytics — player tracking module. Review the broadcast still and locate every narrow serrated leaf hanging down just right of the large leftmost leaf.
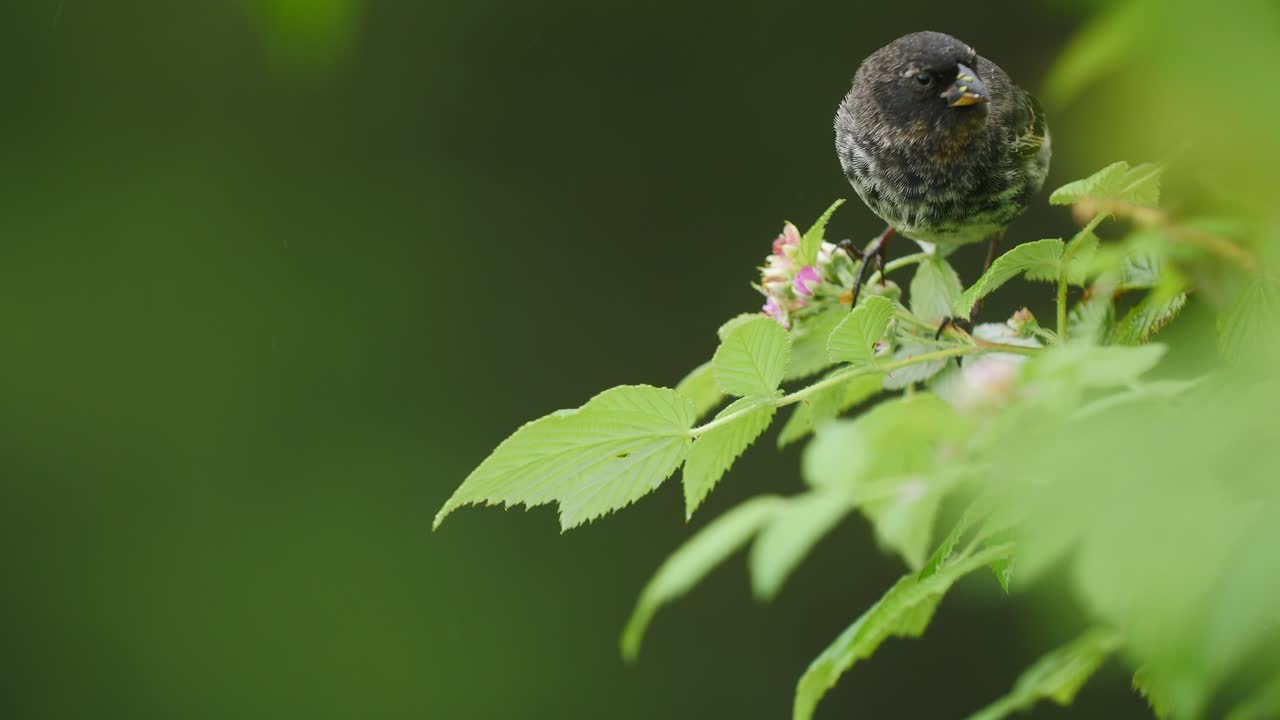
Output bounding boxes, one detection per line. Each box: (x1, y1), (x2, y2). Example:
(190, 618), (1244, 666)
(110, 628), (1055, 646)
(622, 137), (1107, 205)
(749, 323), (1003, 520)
(685, 397), (777, 519)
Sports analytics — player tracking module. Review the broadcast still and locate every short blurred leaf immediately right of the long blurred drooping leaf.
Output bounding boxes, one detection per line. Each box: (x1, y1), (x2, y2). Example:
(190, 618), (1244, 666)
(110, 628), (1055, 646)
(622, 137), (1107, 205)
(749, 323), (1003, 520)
(748, 491), (852, 601)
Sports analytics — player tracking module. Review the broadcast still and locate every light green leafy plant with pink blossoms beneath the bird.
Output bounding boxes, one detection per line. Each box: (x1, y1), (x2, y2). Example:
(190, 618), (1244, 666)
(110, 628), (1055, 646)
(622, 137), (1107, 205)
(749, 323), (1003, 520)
(435, 0), (1280, 720)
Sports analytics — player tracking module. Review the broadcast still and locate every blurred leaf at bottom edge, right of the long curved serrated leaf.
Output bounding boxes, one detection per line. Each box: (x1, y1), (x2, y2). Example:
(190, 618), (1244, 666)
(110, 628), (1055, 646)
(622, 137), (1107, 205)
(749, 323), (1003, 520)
(969, 629), (1120, 720)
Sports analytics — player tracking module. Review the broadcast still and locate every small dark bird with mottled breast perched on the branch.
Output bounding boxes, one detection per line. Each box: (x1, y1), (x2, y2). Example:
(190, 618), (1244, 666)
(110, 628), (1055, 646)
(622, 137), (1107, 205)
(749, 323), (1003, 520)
(836, 32), (1050, 320)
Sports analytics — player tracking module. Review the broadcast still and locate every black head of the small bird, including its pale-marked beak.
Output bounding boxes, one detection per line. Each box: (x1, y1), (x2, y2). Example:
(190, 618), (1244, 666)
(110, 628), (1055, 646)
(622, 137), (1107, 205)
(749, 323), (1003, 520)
(855, 32), (991, 129)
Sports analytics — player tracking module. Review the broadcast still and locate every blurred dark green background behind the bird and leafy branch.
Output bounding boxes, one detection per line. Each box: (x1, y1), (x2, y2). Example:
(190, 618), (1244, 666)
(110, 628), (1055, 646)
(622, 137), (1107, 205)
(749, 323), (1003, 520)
(0, 0), (1146, 719)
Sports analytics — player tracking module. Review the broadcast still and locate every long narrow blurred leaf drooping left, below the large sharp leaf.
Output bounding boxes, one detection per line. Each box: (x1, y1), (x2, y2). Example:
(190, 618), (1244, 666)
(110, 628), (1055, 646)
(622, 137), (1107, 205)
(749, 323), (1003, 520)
(622, 496), (783, 661)
